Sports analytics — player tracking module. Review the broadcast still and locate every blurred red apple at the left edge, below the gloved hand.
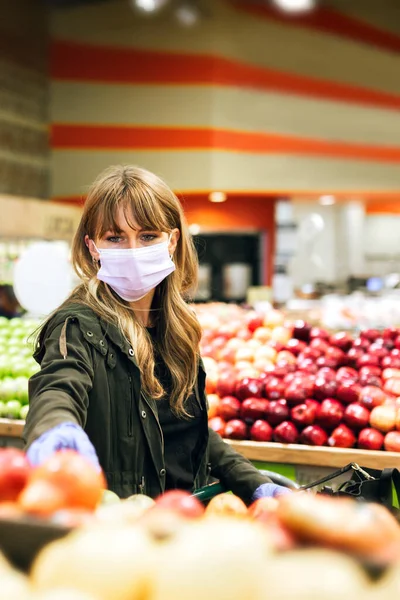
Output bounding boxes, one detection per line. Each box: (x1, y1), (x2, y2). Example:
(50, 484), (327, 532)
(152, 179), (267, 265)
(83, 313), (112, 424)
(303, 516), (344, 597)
(0, 448), (31, 502)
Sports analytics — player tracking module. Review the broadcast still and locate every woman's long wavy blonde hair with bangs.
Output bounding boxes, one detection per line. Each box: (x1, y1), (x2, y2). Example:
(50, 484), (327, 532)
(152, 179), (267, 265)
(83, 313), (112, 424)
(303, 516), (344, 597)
(67, 166), (201, 416)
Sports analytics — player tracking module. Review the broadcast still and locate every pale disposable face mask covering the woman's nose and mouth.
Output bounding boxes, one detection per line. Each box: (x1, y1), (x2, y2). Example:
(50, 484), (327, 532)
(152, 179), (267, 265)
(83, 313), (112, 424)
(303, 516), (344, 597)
(95, 236), (175, 302)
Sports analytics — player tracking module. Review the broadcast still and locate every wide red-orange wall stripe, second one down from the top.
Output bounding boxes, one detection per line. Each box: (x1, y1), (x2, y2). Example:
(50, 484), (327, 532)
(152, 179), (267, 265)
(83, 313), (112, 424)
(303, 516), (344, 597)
(50, 41), (400, 110)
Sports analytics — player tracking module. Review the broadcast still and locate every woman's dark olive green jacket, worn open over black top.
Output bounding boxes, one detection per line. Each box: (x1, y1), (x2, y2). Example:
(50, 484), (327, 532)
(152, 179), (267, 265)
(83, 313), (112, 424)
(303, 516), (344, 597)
(24, 304), (269, 503)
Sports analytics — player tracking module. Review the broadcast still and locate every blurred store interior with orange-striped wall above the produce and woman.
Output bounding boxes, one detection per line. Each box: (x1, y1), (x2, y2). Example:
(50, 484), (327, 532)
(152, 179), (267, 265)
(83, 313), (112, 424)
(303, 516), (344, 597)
(0, 0), (400, 326)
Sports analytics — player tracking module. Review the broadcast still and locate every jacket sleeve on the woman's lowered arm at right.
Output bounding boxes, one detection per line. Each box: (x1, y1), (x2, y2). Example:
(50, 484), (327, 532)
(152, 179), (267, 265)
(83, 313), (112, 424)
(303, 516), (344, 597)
(208, 428), (271, 504)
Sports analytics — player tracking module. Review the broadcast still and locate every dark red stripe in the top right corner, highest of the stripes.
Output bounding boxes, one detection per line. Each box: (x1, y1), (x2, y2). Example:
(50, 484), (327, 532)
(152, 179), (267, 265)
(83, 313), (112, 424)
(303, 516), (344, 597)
(231, 0), (400, 53)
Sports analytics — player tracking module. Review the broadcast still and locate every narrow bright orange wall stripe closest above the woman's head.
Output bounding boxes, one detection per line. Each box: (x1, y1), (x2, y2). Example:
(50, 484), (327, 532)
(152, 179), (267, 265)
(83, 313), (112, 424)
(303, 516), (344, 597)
(51, 124), (400, 163)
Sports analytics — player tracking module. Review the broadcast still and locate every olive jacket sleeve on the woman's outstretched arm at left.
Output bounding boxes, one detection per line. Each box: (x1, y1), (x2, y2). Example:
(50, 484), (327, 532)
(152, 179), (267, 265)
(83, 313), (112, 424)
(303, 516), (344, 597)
(23, 320), (93, 446)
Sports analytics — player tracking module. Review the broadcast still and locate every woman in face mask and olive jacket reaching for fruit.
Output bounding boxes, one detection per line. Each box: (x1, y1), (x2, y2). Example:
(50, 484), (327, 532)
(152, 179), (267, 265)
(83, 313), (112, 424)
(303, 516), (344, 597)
(24, 166), (286, 503)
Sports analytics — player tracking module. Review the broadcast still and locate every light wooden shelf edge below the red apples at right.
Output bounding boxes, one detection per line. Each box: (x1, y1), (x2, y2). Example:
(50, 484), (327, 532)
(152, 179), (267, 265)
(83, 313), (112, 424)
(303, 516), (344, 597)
(225, 440), (400, 469)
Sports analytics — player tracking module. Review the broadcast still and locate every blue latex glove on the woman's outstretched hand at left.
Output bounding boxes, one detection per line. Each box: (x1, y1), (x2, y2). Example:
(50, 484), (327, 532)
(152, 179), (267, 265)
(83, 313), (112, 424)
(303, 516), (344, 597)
(26, 423), (100, 471)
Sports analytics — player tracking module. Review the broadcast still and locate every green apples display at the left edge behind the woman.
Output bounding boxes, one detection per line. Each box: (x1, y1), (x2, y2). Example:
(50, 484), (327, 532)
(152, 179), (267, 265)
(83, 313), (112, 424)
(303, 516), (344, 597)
(0, 317), (39, 420)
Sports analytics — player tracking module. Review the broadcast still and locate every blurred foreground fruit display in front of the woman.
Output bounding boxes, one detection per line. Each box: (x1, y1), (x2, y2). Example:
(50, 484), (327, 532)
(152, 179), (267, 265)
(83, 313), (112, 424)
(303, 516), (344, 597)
(0, 449), (400, 600)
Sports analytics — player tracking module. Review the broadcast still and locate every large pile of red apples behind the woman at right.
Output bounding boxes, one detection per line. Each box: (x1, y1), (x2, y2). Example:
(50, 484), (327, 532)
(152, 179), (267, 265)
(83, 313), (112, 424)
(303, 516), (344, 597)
(199, 307), (400, 452)
